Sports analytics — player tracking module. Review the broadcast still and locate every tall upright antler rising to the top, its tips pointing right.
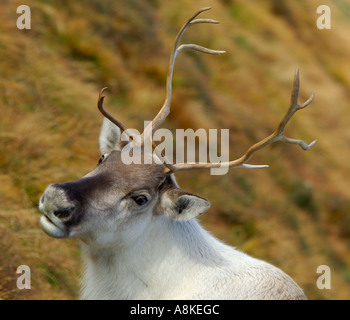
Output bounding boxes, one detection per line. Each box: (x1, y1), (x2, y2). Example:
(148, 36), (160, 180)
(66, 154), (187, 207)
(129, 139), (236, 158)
(141, 7), (225, 145)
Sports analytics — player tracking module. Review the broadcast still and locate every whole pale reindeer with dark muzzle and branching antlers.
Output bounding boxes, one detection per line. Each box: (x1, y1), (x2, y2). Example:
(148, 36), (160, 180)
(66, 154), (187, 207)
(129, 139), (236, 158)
(39, 7), (316, 299)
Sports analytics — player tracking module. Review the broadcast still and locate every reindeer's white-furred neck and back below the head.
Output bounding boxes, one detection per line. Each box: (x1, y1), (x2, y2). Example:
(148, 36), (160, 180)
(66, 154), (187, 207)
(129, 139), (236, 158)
(81, 216), (305, 299)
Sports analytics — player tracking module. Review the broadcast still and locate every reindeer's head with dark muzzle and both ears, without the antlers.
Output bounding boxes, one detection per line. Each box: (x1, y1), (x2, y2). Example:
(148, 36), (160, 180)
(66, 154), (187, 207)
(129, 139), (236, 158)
(39, 119), (209, 245)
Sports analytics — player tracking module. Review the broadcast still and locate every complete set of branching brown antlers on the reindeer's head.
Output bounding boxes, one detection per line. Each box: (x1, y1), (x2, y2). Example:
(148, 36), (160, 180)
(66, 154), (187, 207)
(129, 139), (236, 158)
(98, 7), (317, 173)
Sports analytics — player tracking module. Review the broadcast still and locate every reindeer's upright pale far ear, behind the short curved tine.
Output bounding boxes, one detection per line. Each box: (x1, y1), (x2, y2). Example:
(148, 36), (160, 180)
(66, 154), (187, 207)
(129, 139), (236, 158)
(99, 118), (123, 154)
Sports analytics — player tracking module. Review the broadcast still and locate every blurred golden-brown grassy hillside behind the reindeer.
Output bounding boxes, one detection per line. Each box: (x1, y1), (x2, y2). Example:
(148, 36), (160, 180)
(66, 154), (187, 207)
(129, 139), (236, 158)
(0, 0), (350, 299)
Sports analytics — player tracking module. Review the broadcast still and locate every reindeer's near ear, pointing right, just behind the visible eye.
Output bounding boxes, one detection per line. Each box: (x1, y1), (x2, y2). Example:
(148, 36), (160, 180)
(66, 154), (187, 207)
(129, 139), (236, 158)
(158, 187), (210, 221)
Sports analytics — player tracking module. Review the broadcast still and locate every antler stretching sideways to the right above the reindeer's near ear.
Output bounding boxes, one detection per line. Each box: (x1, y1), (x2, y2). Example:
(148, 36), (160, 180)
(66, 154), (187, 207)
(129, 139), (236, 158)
(166, 69), (317, 173)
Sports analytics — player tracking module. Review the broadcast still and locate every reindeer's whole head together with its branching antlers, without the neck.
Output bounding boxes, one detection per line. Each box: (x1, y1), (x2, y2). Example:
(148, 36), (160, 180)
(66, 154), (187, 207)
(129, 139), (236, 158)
(39, 8), (316, 246)
